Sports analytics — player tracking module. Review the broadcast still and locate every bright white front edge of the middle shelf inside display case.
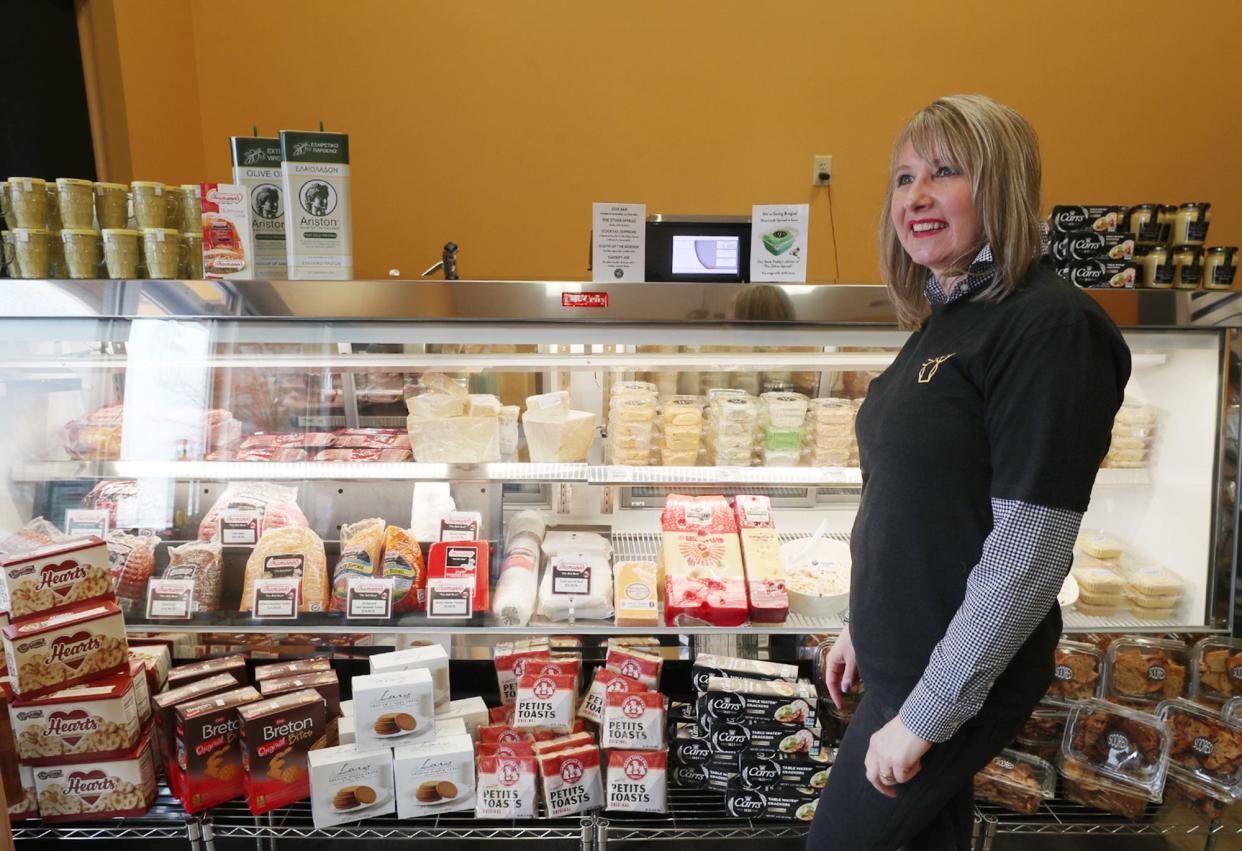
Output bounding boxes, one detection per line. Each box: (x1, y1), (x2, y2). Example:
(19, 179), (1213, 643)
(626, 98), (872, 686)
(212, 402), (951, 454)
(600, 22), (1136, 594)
(10, 461), (1151, 487)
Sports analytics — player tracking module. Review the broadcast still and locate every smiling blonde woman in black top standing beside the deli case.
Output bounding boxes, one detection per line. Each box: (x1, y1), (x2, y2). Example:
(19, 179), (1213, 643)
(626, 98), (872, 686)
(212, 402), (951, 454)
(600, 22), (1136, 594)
(807, 96), (1130, 851)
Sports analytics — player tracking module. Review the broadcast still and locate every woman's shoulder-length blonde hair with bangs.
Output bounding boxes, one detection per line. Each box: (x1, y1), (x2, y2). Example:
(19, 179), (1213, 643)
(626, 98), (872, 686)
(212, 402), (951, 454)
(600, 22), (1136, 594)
(879, 94), (1042, 328)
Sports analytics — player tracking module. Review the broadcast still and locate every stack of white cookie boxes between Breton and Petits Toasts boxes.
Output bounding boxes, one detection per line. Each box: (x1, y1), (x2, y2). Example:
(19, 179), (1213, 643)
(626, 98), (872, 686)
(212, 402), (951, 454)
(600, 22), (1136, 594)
(311, 644), (487, 827)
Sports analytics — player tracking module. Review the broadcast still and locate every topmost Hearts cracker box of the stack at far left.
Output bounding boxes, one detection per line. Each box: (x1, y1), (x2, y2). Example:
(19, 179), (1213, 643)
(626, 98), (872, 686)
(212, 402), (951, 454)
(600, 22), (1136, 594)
(0, 535), (114, 620)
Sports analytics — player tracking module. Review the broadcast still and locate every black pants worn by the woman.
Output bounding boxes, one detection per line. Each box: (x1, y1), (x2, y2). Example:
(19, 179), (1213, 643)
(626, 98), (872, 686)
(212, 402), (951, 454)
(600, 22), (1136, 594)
(806, 692), (1025, 851)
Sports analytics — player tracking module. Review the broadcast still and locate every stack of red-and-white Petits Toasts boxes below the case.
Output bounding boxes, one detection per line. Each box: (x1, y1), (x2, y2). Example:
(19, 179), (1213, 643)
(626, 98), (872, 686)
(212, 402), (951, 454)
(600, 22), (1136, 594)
(486, 639), (667, 819)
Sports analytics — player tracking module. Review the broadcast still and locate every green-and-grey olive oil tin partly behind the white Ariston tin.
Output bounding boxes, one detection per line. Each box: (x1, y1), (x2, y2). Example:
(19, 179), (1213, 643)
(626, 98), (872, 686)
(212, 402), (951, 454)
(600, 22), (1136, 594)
(231, 135), (288, 281)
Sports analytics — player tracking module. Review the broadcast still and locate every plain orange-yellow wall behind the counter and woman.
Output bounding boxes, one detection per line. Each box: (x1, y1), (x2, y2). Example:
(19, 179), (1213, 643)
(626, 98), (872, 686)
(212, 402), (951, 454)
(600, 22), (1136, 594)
(79, 0), (1242, 282)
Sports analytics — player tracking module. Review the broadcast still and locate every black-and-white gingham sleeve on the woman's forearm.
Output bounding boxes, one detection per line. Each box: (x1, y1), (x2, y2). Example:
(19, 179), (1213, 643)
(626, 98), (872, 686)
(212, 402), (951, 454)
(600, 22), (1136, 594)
(900, 499), (1082, 742)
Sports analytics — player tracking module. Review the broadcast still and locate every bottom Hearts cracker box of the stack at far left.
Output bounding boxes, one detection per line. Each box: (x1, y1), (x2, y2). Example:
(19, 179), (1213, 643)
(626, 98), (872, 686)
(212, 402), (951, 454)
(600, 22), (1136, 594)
(34, 737), (155, 824)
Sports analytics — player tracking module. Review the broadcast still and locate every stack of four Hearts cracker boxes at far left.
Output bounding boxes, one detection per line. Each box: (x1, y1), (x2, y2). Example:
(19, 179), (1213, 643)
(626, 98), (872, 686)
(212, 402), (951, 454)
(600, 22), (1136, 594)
(0, 537), (156, 824)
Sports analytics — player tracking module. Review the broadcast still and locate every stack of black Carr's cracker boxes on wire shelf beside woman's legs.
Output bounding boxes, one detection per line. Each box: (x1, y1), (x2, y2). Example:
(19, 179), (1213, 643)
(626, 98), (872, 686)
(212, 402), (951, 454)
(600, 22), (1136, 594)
(668, 653), (830, 821)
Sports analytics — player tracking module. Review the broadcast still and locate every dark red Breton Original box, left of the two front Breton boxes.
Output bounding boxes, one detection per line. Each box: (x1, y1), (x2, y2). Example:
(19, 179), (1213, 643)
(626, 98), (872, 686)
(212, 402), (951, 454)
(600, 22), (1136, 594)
(176, 686), (260, 812)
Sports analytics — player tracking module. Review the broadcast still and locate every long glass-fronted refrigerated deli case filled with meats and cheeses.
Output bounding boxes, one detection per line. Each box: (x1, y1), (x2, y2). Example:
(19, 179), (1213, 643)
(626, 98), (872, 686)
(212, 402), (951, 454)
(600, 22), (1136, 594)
(0, 281), (1238, 846)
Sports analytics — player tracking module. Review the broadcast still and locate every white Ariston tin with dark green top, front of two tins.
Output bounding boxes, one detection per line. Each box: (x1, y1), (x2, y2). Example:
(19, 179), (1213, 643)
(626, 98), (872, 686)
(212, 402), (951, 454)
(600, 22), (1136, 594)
(281, 130), (354, 281)
